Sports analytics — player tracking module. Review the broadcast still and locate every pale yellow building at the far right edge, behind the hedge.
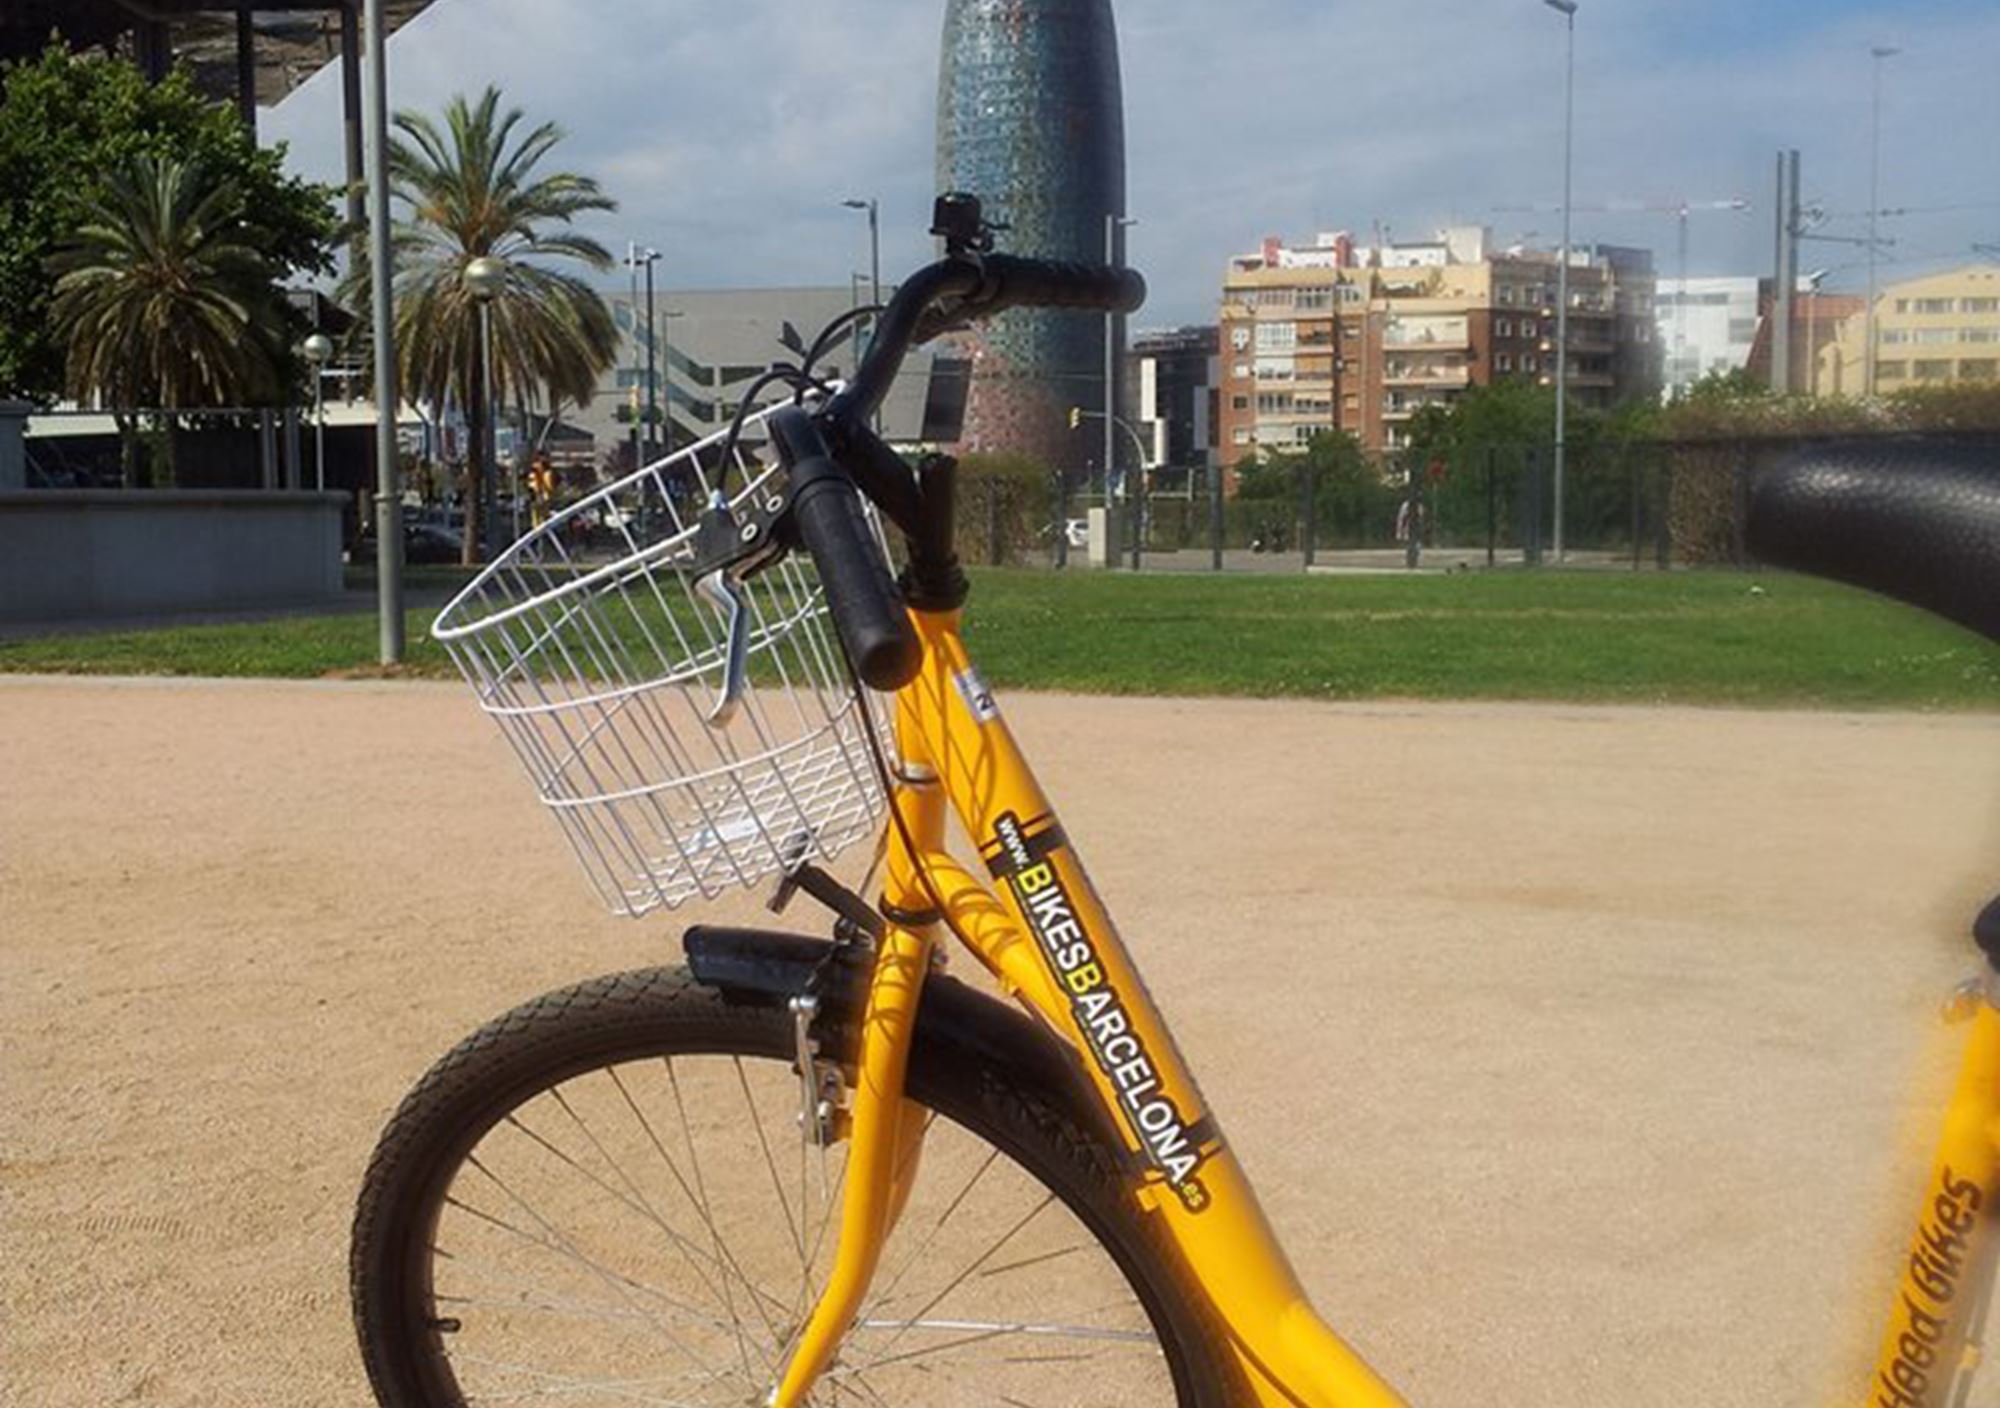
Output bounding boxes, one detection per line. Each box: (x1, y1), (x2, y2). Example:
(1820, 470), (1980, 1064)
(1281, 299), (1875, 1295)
(1816, 264), (2000, 396)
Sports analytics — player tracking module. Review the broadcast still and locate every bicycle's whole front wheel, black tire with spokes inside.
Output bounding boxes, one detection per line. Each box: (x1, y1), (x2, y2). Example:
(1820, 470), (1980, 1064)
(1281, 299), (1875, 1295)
(350, 968), (1220, 1408)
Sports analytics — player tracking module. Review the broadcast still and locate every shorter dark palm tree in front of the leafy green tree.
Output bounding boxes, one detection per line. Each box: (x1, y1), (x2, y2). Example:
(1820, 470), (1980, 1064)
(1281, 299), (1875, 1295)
(50, 156), (286, 486)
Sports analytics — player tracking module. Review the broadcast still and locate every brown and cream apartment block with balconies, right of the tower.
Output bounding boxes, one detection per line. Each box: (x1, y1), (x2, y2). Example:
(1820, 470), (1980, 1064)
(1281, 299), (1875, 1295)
(1218, 226), (1658, 462)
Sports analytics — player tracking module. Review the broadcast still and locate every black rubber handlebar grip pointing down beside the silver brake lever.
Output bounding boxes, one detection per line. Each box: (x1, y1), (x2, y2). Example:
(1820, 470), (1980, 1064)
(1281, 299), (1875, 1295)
(770, 408), (924, 692)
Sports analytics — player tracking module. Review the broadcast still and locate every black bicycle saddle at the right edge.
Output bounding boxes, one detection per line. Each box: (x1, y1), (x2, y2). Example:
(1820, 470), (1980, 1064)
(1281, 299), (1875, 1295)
(1744, 440), (2000, 640)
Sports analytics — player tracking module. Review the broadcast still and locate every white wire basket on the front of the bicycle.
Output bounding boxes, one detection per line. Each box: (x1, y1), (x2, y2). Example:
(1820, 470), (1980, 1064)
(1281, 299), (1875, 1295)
(432, 398), (892, 916)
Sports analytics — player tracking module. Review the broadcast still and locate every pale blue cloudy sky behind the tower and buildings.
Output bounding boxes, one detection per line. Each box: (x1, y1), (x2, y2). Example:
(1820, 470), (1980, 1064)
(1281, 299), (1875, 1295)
(260, 0), (2000, 326)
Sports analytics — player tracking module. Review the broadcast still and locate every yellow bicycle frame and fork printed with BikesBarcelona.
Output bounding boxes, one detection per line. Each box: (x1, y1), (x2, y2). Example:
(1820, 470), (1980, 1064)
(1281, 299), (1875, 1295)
(770, 612), (2000, 1408)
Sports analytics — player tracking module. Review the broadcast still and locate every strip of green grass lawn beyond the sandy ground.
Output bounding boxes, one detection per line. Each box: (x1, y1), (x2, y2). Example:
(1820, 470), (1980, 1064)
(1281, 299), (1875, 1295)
(0, 572), (2000, 710)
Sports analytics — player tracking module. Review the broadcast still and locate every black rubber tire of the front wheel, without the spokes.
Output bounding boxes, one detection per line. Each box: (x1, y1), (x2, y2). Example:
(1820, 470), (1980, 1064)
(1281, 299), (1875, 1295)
(348, 966), (1230, 1408)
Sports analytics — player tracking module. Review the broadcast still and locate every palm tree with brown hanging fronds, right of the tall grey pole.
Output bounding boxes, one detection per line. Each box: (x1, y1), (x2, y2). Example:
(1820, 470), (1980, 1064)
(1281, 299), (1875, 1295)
(350, 88), (618, 566)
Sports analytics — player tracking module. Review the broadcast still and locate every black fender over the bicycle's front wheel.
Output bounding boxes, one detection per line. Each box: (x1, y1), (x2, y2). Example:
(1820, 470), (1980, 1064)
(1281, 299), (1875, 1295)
(680, 924), (1130, 1158)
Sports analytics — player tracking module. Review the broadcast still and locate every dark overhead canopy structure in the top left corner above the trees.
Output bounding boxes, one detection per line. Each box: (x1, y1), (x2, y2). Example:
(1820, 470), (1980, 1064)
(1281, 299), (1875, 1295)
(0, 0), (430, 110)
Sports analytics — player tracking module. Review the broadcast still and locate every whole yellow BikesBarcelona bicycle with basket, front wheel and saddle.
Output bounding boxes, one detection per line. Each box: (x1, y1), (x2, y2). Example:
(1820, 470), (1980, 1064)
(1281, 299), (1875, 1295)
(352, 198), (2000, 1408)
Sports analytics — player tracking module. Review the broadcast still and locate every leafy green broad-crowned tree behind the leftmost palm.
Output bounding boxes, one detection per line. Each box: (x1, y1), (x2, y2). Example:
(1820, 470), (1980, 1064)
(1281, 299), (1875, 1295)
(0, 44), (336, 402)
